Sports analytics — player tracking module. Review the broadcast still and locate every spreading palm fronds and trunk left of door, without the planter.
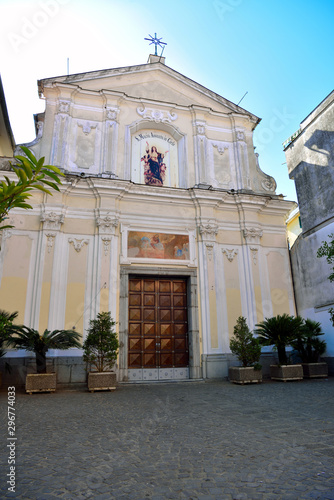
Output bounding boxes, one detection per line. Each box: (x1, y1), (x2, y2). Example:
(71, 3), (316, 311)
(9, 326), (81, 373)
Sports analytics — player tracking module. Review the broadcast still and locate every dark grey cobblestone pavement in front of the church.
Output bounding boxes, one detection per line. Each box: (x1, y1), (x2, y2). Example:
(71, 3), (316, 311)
(0, 379), (334, 500)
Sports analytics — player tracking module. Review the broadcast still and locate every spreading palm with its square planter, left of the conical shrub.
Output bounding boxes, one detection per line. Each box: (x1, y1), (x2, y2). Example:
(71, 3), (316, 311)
(9, 326), (81, 394)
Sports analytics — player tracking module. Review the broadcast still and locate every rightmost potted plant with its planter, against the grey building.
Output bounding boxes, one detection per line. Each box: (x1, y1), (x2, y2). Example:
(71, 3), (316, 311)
(291, 319), (328, 378)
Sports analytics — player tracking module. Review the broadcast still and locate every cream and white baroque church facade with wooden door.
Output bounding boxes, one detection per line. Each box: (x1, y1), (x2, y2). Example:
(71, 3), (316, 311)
(0, 55), (295, 381)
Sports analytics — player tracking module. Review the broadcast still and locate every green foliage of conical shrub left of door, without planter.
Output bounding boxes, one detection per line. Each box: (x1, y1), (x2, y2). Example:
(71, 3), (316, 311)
(83, 312), (119, 372)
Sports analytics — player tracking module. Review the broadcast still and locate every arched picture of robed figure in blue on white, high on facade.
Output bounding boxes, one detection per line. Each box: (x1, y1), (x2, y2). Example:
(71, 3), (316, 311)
(131, 130), (178, 187)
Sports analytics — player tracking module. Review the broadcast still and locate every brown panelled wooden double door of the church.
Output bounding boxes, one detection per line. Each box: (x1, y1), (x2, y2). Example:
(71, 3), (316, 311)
(128, 277), (189, 369)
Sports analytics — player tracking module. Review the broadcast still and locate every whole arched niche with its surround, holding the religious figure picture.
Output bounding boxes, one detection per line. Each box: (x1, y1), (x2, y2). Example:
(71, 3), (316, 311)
(124, 119), (188, 188)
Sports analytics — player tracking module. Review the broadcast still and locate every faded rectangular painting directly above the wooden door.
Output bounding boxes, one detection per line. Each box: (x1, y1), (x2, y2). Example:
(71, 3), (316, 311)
(128, 231), (189, 260)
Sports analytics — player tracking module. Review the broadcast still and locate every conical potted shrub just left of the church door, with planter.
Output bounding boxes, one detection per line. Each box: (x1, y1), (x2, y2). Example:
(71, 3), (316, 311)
(83, 312), (119, 392)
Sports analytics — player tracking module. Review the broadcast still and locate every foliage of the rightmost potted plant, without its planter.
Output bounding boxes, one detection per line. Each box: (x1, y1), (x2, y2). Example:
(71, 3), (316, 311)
(291, 319), (326, 363)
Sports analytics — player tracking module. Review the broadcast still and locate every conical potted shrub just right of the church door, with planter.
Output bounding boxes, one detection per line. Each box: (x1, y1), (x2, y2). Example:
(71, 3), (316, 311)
(229, 316), (262, 384)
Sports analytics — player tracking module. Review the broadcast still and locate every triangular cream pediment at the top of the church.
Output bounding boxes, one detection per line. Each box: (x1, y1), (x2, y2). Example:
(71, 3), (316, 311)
(39, 63), (258, 121)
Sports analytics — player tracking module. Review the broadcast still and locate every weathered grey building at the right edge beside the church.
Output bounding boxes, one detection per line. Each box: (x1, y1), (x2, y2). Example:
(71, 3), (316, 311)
(284, 91), (334, 372)
